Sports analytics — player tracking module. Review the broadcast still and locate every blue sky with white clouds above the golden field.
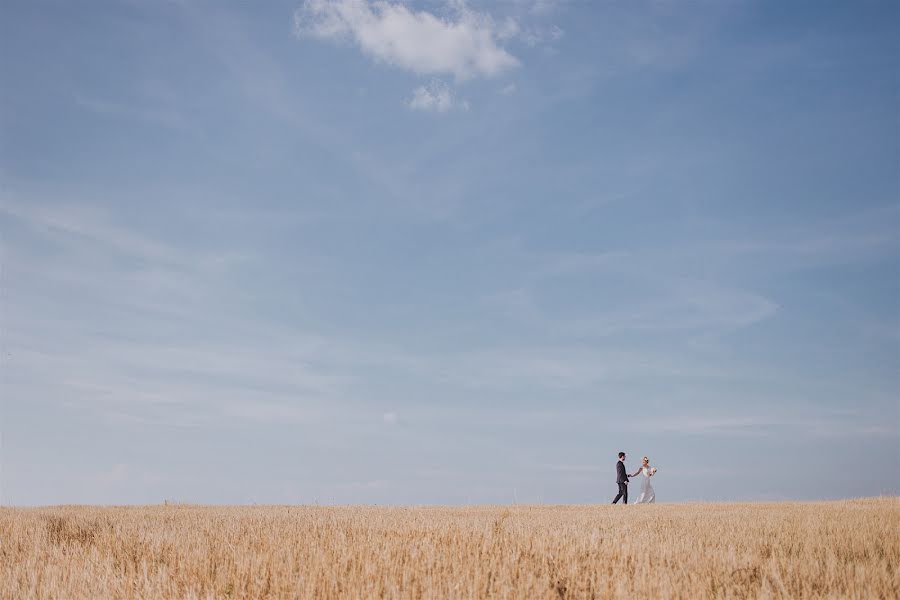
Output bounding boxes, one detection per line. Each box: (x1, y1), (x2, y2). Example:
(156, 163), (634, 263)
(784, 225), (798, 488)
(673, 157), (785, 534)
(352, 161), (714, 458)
(0, 0), (900, 505)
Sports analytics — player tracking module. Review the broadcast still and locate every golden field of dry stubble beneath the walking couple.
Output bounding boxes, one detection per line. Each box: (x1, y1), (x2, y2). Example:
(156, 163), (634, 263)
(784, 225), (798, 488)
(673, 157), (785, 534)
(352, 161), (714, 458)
(0, 498), (900, 599)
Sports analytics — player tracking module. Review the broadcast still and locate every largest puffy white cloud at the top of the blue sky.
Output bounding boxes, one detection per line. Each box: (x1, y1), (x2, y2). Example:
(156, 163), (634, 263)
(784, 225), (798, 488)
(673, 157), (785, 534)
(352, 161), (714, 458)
(294, 0), (519, 80)
